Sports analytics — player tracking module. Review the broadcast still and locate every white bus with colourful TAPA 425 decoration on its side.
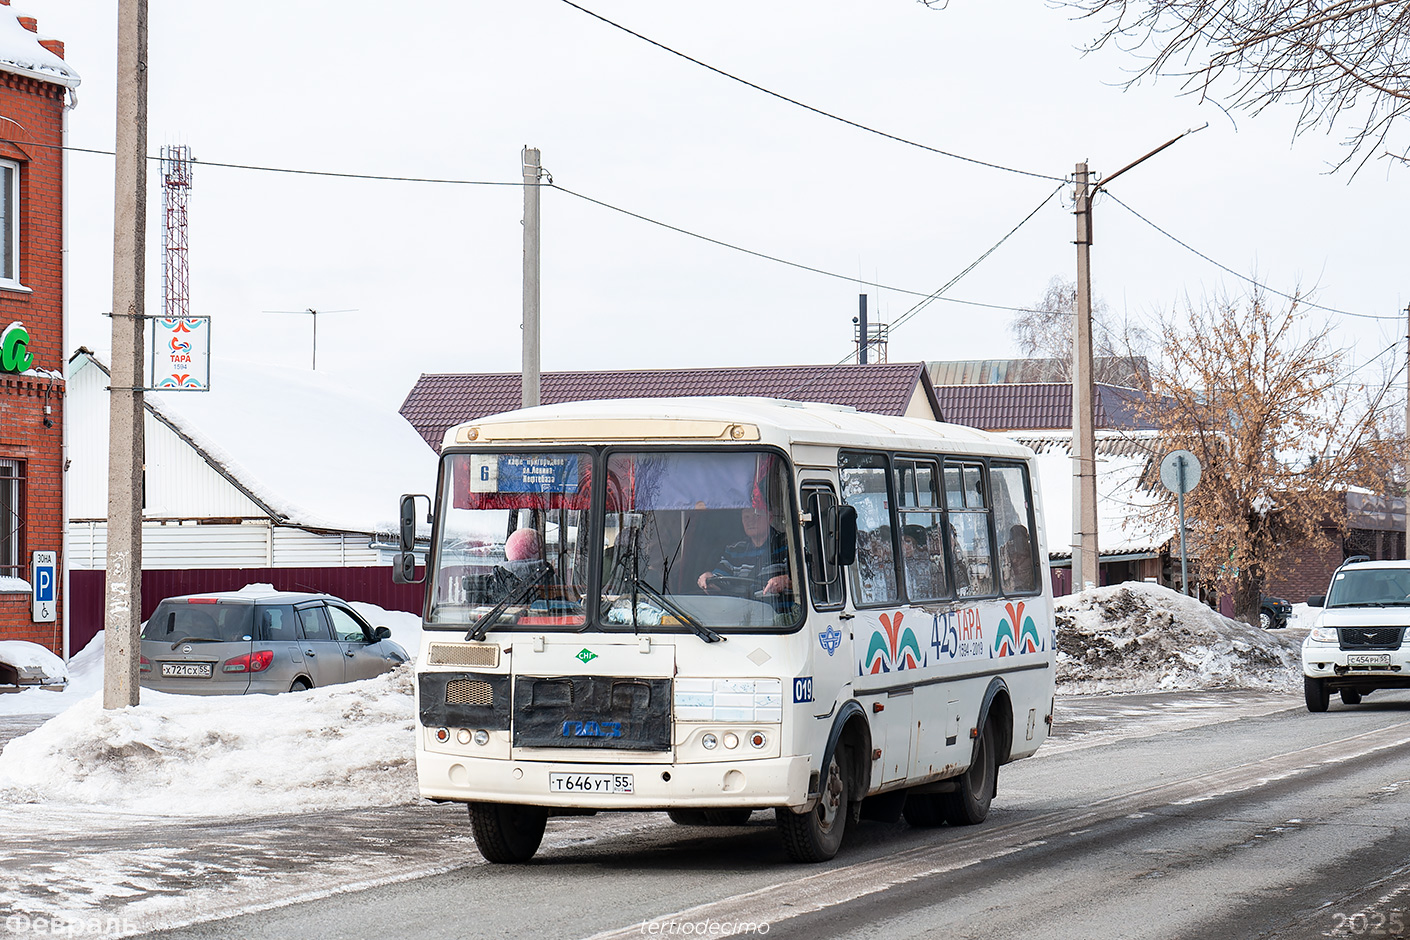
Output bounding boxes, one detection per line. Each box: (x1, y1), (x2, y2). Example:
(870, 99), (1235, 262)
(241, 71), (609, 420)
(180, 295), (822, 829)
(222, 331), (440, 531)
(395, 397), (1055, 862)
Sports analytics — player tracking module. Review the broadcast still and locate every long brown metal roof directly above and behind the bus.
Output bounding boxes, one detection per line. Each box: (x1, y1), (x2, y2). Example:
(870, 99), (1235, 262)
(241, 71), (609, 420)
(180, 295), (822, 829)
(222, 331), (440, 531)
(402, 362), (942, 451)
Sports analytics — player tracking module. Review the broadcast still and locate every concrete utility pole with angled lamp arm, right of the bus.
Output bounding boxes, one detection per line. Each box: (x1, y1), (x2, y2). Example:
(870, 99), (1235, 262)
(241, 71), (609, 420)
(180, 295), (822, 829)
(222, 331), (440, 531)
(1072, 162), (1101, 590)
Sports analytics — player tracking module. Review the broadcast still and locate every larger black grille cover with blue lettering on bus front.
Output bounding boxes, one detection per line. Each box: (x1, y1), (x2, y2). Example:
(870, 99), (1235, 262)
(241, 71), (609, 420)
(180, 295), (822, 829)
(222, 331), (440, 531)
(513, 675), (671, 751)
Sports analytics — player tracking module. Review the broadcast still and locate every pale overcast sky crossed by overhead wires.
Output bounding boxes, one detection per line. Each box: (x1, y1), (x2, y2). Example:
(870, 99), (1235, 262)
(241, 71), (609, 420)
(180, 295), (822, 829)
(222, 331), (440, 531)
(27, 0), (1410, 402)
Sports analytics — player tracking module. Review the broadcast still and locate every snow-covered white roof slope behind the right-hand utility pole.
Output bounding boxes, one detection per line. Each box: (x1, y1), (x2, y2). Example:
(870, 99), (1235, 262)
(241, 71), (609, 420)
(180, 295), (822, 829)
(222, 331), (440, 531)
(1010, 433), (1176, 558)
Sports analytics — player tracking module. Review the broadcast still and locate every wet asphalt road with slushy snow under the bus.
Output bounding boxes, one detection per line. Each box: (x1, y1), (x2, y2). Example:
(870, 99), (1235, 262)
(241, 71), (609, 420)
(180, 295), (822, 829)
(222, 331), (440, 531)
(8, 692), (1410, 940)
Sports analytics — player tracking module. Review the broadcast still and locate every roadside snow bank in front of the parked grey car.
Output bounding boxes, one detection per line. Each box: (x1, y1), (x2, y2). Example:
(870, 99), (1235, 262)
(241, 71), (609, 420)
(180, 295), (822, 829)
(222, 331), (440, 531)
(0, 665), (420, 816)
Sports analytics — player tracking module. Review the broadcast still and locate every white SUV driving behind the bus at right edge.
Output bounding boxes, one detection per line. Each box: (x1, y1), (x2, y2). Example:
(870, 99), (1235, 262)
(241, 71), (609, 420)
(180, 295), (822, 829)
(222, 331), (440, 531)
(1303, 555), (1410, 712)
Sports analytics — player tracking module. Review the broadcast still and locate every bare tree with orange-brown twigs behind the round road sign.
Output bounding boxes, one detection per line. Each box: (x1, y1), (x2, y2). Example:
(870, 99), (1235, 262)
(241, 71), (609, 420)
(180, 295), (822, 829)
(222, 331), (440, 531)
(1142, 295), (1399, 623)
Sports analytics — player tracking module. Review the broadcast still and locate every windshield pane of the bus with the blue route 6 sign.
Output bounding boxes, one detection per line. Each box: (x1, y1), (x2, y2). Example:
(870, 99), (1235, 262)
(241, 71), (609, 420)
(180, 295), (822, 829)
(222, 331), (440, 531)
(427, 452), (592, 629)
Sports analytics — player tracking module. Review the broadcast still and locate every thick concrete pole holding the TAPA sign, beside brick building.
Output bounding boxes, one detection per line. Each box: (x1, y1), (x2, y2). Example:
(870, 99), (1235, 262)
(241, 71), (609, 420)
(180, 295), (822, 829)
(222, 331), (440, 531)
(103, 0), (147, 709)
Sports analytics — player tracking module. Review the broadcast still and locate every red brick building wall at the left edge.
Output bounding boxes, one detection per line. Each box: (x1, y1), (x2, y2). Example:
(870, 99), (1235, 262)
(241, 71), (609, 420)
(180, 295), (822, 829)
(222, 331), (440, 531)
(0, 57), (66, 655)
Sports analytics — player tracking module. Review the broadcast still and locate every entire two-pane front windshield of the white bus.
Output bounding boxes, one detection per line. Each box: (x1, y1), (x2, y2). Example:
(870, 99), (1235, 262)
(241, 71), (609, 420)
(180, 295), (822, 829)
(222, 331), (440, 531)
(426, 448), (804, 638)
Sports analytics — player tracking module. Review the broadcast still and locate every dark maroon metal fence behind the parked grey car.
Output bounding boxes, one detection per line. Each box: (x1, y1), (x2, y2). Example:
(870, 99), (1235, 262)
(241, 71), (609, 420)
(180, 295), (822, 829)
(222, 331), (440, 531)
(68, 567), (426, 653)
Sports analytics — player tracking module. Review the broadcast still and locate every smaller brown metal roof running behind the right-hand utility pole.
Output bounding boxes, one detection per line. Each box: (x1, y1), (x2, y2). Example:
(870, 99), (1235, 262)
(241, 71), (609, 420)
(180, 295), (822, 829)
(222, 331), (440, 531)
(935, 382), (1155, 431)
